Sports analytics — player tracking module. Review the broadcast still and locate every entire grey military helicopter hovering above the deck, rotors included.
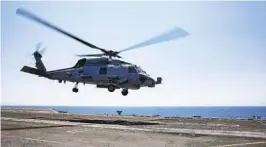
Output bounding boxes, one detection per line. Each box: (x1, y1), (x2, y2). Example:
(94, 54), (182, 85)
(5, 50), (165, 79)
(16, 8), (189, 96)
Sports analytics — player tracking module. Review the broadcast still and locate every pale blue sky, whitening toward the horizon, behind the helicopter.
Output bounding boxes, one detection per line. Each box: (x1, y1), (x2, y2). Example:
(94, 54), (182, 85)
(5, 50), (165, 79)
(1, 1), (266, 106)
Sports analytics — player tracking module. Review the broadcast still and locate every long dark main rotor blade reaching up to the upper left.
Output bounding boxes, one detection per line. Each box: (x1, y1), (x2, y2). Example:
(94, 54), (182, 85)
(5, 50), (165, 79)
(17, 8), (106, 52)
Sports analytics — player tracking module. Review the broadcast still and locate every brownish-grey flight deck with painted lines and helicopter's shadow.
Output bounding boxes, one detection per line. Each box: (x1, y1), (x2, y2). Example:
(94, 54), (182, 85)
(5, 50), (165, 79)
(1, 108), (266, 147)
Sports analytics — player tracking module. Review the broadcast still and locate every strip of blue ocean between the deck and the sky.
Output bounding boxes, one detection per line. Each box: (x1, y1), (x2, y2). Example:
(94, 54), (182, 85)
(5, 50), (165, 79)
(1, 106), (266, 120)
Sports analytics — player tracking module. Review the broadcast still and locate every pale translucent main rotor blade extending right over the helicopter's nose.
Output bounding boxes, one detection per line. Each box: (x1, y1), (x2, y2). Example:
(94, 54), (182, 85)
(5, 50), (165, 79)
(119, 27), (189, 53)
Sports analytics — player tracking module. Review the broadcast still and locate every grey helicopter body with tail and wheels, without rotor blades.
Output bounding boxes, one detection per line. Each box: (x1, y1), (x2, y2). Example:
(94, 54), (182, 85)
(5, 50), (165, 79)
(21, 56), (162, 95)
